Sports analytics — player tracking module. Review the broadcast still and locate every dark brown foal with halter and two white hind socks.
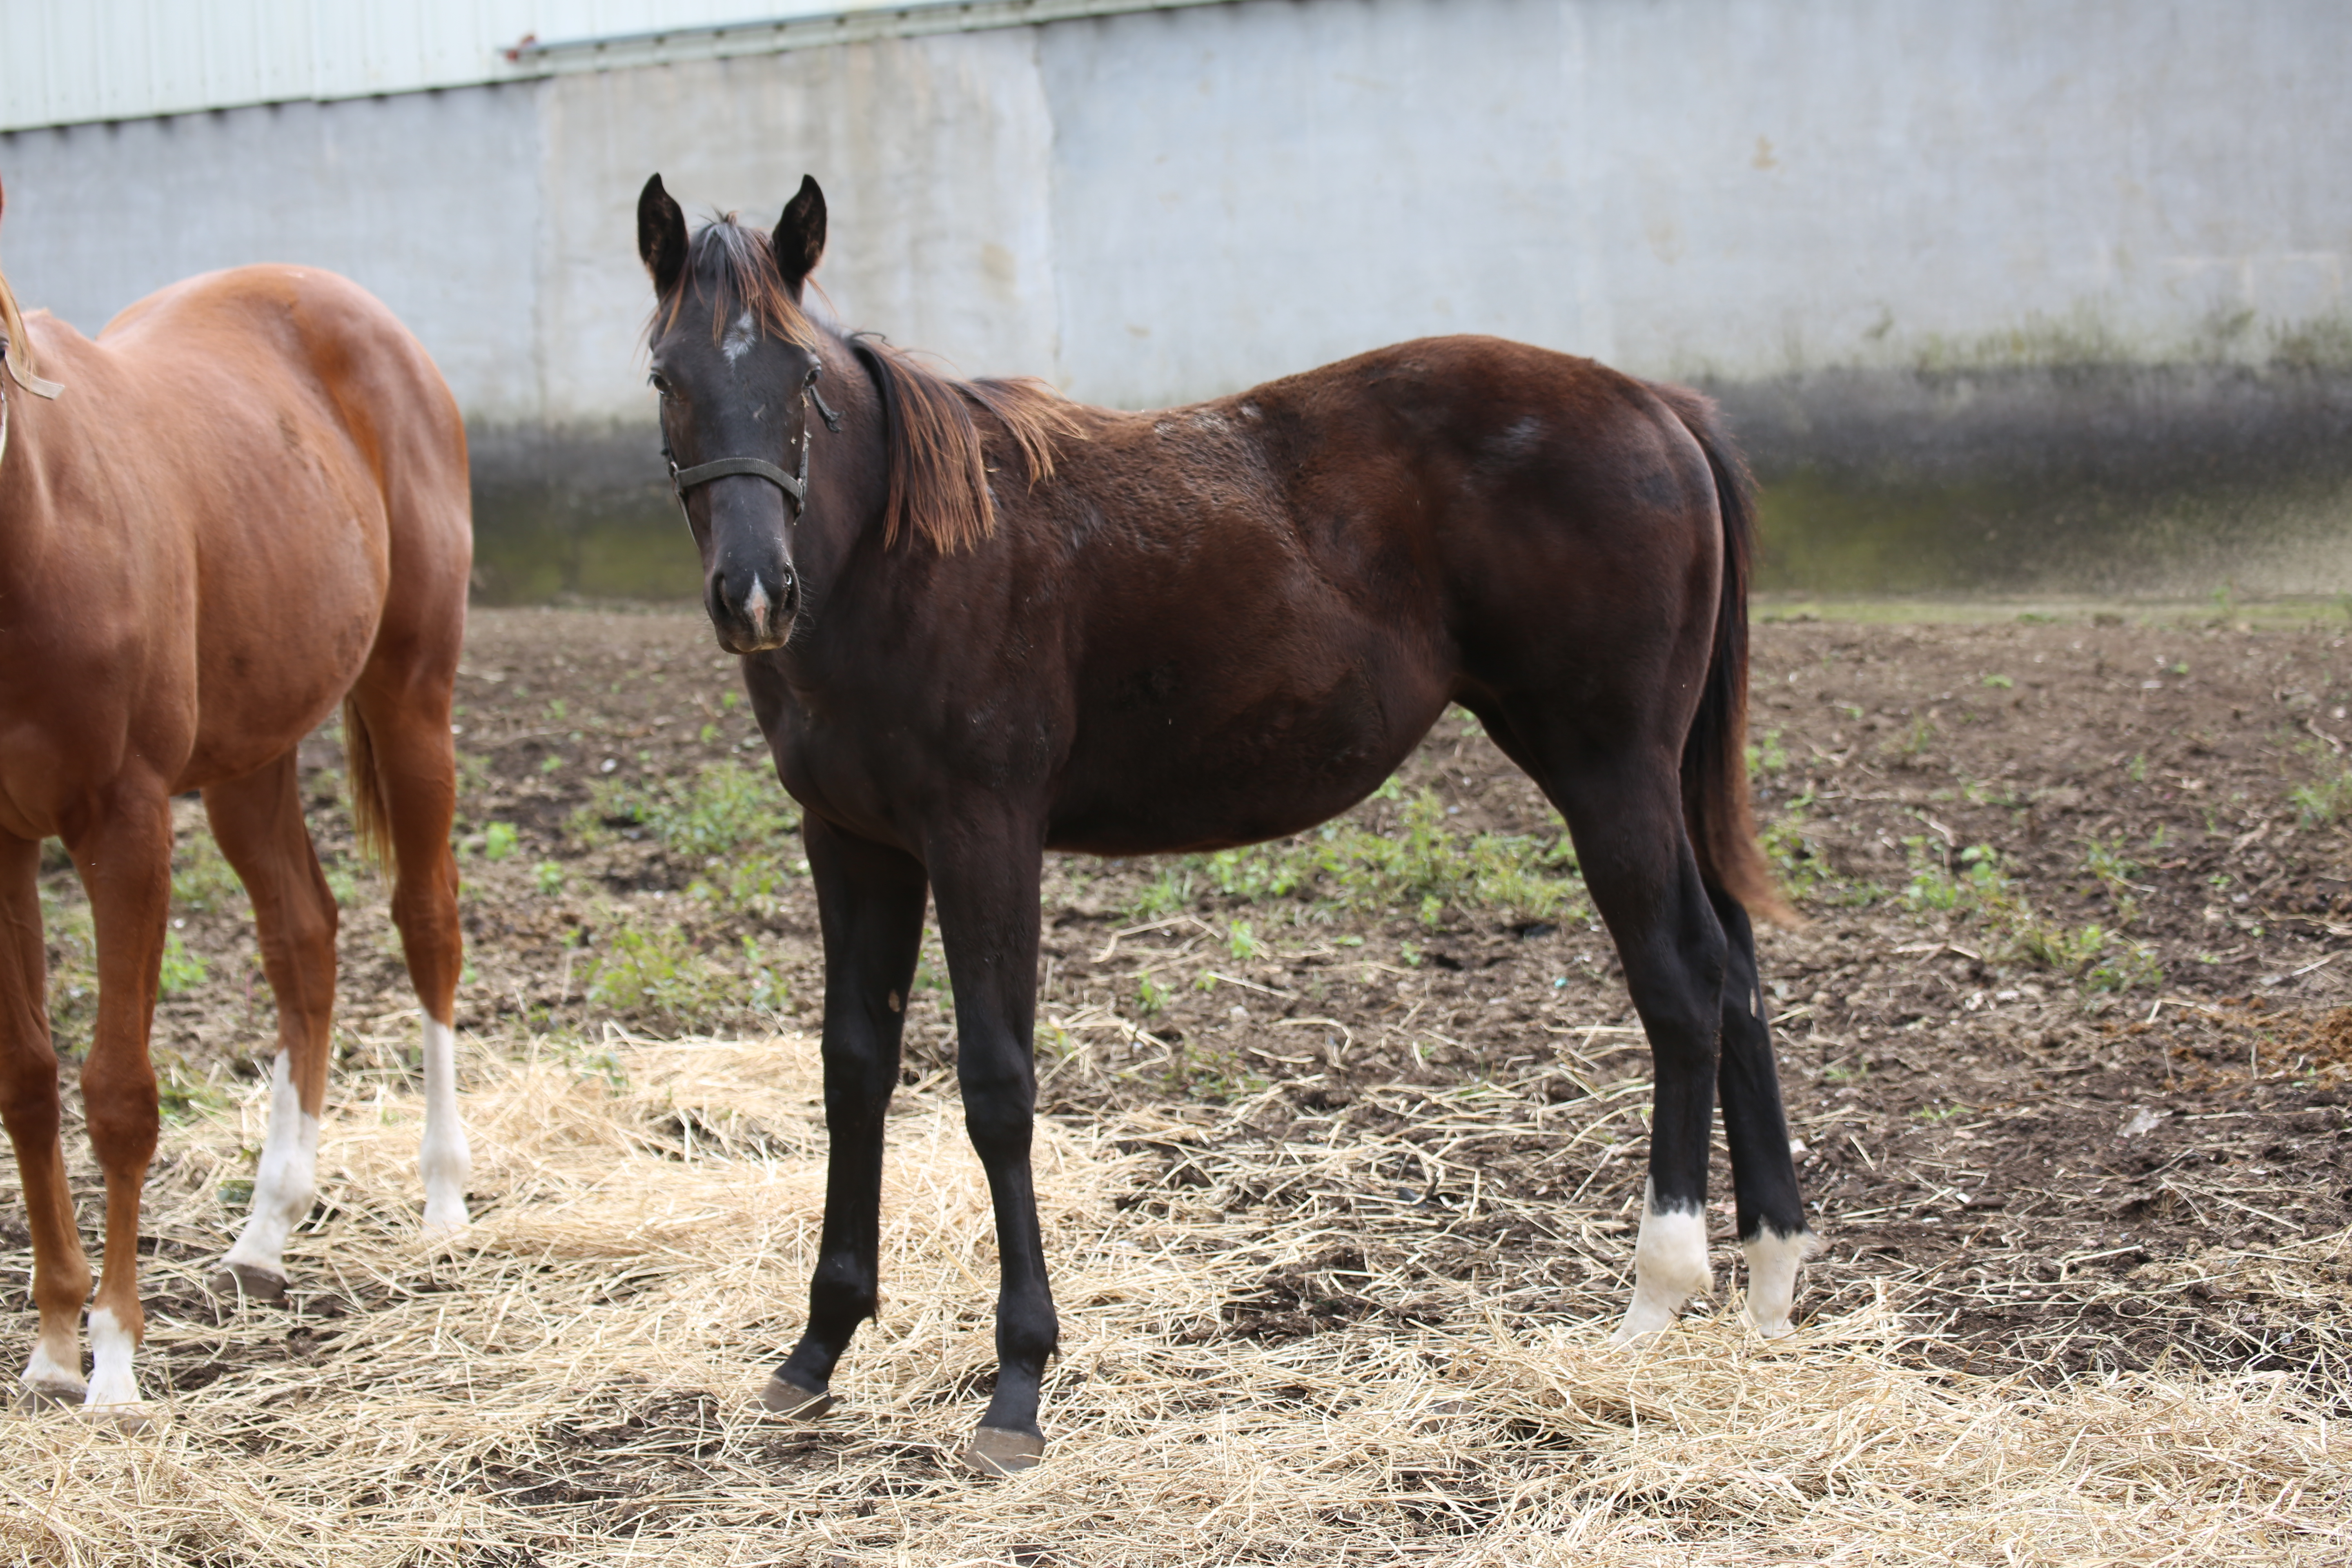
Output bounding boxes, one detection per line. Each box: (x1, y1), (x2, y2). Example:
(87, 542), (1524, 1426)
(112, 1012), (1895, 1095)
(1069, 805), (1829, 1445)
(637, 176), (1811, 1472)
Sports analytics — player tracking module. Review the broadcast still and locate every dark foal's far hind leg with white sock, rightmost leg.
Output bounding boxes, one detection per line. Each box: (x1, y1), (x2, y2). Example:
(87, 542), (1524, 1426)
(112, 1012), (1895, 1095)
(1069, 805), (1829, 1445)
(1708, 889), (1816, 1340)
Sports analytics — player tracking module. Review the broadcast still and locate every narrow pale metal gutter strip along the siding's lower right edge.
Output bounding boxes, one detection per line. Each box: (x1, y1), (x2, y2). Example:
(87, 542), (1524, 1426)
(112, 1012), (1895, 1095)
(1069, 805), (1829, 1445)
(513, 0), (1232, 75)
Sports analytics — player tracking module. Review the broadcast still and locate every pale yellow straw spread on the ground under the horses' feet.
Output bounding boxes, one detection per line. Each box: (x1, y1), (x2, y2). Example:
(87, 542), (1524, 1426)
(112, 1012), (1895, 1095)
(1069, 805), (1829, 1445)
(0, 1039), (2352, 1568)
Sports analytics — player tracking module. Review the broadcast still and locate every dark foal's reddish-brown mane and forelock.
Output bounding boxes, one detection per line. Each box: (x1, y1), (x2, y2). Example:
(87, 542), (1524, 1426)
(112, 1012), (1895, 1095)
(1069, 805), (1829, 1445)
(652, 212), (1087, 550)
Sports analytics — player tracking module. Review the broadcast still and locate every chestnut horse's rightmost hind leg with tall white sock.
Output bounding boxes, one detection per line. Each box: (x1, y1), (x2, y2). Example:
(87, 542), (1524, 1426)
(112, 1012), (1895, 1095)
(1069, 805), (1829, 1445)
(343, 686), (473, 1236)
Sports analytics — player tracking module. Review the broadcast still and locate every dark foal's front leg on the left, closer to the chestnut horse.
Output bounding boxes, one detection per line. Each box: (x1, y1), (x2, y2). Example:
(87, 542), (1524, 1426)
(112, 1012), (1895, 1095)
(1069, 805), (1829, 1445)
(760, 813), (927, 1418)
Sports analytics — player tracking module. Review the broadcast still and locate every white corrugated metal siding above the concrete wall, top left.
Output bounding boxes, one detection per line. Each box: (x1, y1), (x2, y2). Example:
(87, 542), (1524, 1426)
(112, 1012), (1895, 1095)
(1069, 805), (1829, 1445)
(0, 0), (1223, 131)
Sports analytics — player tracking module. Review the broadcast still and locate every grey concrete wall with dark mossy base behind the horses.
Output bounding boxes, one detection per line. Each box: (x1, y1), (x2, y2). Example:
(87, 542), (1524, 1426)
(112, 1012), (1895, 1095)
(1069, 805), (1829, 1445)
(0, 0), (2352, 592)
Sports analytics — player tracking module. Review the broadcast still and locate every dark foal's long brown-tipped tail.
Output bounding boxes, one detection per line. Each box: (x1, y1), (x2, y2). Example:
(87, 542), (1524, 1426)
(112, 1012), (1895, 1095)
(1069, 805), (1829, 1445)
(1651, 385), (1799, 926)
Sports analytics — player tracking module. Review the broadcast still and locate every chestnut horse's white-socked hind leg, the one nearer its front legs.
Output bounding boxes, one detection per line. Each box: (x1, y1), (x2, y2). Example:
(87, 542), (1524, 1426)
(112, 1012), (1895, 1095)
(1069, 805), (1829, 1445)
(205, 752), (336, 1300)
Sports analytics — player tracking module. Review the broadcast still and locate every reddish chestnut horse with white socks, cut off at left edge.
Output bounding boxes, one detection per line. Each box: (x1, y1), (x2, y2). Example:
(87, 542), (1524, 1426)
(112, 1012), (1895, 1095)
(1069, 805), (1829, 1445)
(0, 190), (473, 1425)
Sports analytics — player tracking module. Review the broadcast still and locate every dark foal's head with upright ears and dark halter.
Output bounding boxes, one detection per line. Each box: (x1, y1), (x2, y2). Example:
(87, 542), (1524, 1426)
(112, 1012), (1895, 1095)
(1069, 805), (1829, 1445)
(637, 174), (826, 653)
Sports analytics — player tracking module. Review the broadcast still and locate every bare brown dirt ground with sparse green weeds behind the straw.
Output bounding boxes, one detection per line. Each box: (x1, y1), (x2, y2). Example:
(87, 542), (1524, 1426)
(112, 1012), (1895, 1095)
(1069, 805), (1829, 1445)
(18, 609), (2352, 1403)
